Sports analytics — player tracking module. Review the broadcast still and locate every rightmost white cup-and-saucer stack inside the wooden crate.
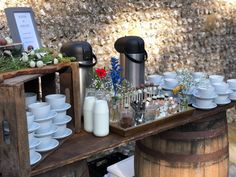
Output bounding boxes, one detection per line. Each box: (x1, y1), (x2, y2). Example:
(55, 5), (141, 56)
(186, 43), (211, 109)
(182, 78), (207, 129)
(45, 94), (72, 139)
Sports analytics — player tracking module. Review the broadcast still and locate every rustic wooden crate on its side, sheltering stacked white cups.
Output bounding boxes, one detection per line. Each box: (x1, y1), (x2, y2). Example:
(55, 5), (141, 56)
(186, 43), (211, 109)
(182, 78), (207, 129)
(0, 62), (81, 177)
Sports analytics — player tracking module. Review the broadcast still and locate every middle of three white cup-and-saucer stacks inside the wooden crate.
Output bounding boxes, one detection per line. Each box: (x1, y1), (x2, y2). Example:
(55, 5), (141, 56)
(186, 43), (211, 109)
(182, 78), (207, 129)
(28, 102), (59, 152)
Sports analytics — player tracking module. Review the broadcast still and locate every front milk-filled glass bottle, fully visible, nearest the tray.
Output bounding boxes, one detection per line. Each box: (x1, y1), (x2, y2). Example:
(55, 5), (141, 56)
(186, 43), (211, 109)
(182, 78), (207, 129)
(93, 91), (109, 137)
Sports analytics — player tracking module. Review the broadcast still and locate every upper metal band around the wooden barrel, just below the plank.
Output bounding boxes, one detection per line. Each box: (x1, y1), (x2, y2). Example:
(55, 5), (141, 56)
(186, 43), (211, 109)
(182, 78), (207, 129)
(160, 126), (227, 140)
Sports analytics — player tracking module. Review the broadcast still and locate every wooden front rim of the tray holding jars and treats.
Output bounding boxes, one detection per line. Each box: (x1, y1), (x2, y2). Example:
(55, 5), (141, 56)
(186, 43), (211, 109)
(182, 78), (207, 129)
(110, 107), (195, 137)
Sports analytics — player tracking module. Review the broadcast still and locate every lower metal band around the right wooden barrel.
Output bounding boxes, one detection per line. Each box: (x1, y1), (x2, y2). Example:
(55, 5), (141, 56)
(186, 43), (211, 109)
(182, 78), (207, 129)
(136, 142), (229, 163)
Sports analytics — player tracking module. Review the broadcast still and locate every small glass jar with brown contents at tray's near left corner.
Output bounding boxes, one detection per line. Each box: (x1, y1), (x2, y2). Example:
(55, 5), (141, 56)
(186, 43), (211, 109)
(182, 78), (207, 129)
(119, 107), (134, 128)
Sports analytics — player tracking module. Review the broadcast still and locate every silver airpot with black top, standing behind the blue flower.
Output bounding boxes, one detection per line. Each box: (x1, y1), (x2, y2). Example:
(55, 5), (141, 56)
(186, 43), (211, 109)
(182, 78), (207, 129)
(115, 36), (147, 86)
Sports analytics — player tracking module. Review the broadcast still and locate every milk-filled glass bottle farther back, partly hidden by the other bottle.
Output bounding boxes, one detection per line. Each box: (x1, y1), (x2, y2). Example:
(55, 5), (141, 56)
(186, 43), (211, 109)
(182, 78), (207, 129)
(83, 88), (96, 132)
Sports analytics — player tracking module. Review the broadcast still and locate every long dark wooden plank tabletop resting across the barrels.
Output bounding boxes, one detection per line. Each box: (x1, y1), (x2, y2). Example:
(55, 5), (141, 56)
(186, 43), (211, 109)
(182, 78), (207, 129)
(31, 102), (236, 176)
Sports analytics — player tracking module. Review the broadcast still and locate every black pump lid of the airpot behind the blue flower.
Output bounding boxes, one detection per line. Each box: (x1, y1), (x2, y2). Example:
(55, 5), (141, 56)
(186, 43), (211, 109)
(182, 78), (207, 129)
(114, 36), (145, 54)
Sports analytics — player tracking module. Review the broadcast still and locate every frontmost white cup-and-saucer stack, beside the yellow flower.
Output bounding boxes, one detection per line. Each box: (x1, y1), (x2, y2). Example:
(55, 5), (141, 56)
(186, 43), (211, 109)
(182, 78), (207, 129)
(192, 86), (217, 109)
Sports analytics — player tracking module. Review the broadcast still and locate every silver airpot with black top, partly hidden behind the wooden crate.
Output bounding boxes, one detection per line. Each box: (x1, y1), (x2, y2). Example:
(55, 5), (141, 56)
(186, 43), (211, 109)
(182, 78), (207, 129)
(61, 41), (97, 113)
